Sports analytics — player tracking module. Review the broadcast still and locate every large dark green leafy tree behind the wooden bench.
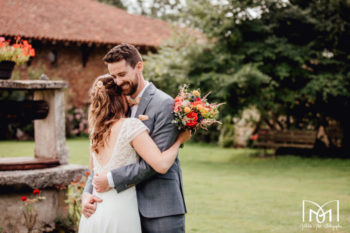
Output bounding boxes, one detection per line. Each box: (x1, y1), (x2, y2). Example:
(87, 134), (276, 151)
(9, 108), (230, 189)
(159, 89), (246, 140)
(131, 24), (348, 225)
(144, 0), (350, 150)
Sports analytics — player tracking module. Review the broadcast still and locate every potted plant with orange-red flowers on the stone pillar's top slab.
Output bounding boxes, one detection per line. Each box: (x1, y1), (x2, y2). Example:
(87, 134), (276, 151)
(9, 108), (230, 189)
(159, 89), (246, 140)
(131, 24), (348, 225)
(0, 36), (35, 79)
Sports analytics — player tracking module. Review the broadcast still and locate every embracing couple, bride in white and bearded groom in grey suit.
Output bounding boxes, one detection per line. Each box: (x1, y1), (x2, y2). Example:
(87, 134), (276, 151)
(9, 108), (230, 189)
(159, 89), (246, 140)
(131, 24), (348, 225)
(79, 44), (191, 233)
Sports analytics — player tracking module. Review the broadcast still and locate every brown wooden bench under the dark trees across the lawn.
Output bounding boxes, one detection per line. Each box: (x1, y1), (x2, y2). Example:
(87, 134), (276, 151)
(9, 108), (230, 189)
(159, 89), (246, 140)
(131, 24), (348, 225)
(253, 130), (317, 152)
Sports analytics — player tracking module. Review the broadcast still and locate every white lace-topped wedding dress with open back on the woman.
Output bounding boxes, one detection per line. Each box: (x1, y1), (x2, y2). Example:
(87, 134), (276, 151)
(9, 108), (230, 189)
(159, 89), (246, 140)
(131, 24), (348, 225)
(79, 118), (148, 233)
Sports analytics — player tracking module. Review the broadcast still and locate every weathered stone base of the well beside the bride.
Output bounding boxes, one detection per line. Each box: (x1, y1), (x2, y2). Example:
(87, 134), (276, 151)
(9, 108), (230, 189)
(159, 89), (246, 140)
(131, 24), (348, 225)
(0, 165), (87, 233)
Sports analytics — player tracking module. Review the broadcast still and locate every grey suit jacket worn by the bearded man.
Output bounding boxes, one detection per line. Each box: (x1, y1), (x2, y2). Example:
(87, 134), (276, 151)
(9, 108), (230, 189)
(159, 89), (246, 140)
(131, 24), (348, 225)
(84, 83), (186, 218)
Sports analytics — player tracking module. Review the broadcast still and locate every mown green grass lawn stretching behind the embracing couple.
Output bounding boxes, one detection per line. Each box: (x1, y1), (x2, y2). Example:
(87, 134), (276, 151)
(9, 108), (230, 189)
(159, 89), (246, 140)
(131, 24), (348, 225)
(0, 139), (350, 233)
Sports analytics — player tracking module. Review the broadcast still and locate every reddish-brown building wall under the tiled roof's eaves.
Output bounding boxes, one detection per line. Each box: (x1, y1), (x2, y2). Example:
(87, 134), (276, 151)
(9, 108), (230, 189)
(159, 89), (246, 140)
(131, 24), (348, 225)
(12, 41), (153, 108)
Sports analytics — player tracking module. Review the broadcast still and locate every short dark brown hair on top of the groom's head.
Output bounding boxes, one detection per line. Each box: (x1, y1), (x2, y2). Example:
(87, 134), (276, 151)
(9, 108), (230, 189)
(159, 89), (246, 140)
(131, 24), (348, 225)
(103, 44), (142, 68)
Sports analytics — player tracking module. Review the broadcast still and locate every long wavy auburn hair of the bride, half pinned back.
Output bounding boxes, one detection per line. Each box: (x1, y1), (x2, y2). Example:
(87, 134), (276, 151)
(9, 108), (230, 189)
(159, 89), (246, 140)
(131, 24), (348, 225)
(88, 75), (127, 153)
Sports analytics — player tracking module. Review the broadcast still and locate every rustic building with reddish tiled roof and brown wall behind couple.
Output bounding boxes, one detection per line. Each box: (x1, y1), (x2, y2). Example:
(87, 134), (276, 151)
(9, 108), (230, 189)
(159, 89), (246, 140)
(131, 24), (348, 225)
(0, 0), (171, 108)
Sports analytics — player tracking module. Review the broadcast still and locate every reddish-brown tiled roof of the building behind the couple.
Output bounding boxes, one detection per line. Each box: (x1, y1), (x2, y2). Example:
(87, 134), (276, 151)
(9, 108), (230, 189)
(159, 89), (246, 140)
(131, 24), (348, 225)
(0, 0), (171, 46)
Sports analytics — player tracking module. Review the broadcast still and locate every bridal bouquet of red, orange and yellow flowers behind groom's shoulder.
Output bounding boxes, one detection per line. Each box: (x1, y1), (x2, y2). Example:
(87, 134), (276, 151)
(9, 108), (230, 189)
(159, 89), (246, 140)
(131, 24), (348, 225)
(173, 85), (222, 132)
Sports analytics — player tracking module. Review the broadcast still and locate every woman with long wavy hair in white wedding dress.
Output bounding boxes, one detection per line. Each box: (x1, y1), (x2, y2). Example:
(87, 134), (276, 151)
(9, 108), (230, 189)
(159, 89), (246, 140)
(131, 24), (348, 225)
(79, 76), (191, 233)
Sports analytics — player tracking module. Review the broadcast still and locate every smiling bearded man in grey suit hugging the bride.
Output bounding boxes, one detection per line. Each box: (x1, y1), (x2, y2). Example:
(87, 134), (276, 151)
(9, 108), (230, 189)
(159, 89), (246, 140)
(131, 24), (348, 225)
(82, 44), (186, 233)
